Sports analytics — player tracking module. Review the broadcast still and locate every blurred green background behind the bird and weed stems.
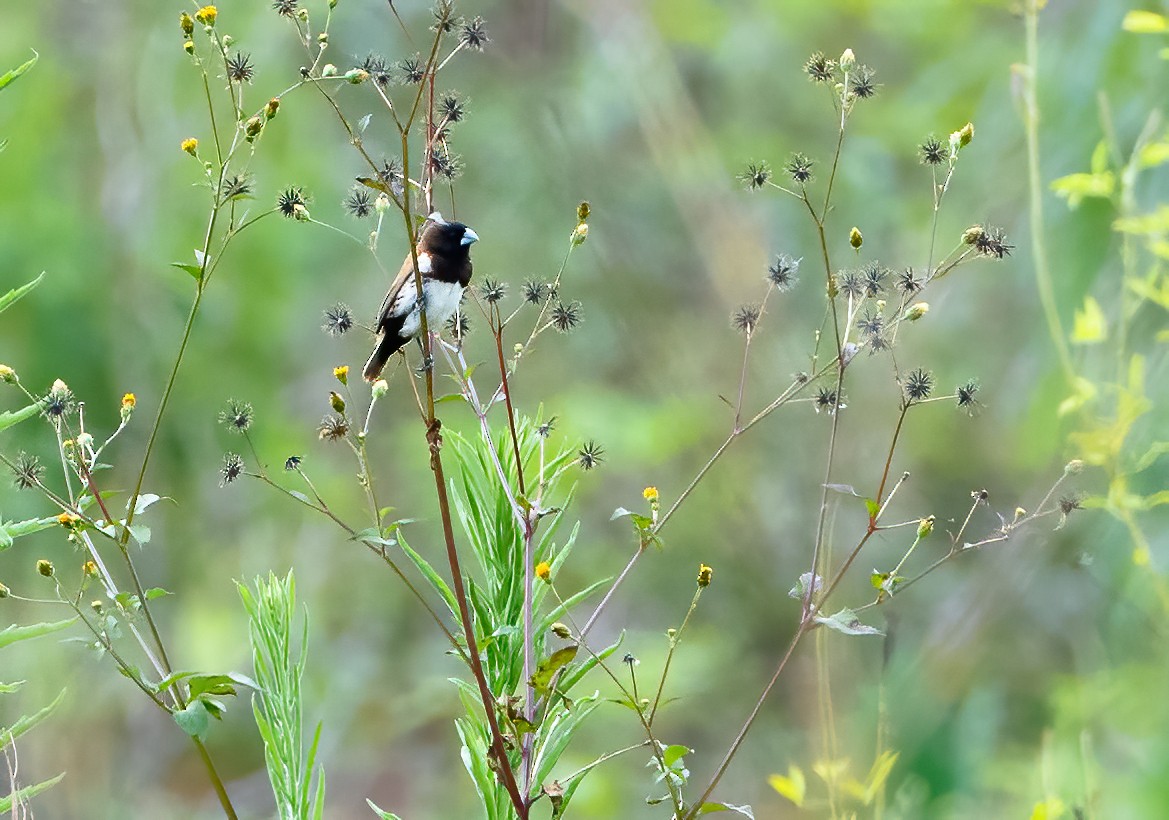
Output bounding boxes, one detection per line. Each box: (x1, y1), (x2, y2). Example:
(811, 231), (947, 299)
(0, 0), (1169, 818)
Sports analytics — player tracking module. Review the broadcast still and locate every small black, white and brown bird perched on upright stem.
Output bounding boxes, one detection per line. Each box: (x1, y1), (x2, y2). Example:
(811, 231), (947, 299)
(364, 213), (479, 381)
